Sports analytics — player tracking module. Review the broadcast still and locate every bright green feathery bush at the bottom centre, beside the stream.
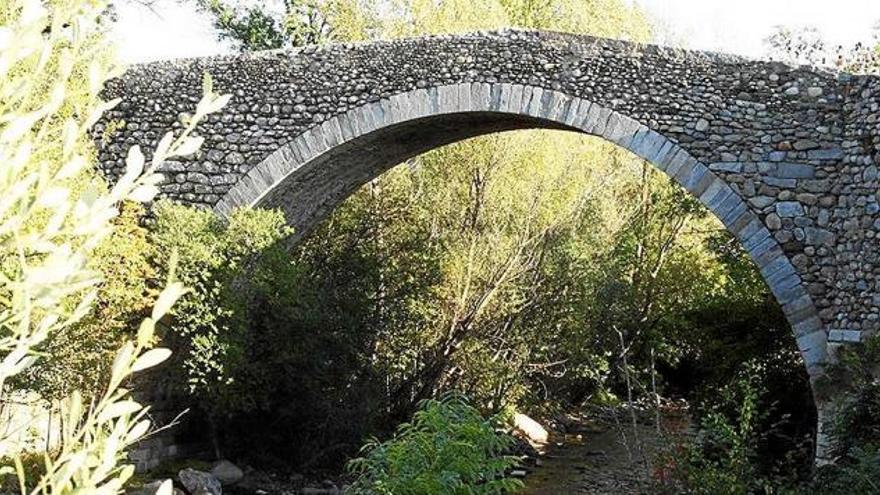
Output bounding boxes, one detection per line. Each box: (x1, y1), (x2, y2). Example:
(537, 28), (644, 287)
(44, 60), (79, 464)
(349, 395), (522, 495)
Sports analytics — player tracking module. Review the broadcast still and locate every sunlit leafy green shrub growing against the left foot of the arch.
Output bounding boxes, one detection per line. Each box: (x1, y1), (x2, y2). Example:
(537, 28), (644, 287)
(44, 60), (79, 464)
(151, 201), (290, 414)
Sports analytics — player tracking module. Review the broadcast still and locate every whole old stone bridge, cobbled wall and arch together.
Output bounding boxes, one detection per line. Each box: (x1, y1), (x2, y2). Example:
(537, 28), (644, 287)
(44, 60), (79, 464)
(96, 31), (880, 458)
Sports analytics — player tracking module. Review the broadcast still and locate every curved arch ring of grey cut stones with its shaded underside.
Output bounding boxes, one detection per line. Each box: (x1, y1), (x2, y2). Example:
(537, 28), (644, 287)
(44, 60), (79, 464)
(215, 83), (828, 380)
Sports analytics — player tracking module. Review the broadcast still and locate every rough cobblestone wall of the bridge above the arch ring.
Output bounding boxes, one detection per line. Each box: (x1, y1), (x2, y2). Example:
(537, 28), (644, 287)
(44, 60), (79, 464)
(95, 31), (880, 352)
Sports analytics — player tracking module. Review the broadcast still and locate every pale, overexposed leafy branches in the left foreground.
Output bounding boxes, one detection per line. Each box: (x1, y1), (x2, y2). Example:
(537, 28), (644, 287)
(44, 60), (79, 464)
(0, 0), (229, 494)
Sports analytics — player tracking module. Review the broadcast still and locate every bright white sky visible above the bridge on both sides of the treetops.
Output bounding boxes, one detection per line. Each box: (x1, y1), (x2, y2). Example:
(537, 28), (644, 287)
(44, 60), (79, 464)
(113, 0), (880, 63)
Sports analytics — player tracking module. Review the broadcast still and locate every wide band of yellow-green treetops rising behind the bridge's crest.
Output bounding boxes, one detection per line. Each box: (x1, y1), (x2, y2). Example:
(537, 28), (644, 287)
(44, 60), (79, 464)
(191, 0), (652, 51)
